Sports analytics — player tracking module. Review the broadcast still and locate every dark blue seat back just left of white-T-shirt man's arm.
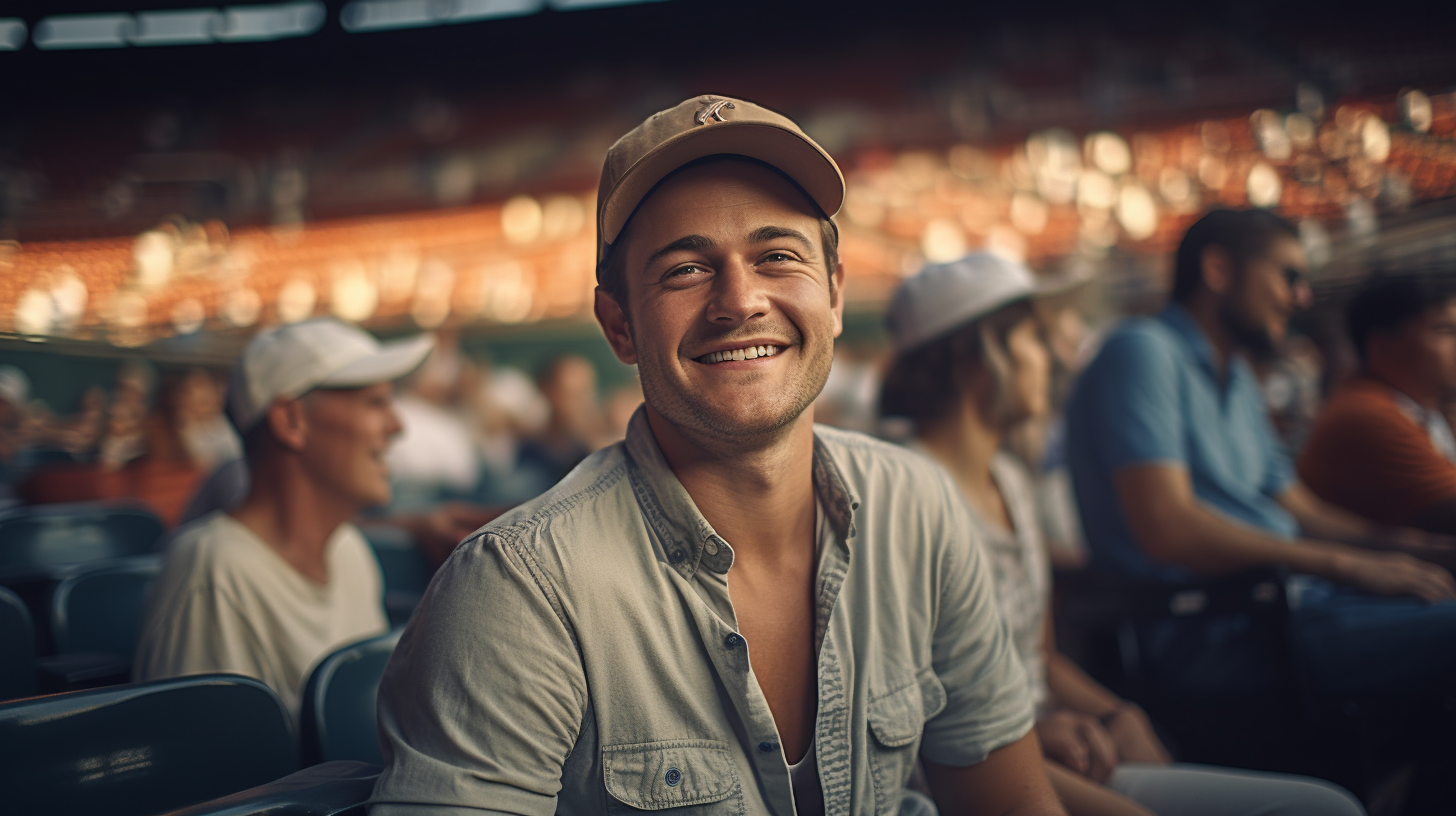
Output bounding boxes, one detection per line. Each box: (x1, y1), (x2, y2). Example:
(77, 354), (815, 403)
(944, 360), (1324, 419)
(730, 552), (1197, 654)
(51, 558), (162, 660)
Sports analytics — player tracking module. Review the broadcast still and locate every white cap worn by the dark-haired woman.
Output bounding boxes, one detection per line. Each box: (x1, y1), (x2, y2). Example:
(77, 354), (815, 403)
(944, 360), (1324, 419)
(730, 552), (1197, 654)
(885, 252), (1038, 354)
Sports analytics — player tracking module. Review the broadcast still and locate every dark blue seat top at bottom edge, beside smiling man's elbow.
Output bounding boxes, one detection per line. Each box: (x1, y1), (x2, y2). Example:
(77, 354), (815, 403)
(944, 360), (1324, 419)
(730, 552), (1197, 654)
(167, 762), (380, 816)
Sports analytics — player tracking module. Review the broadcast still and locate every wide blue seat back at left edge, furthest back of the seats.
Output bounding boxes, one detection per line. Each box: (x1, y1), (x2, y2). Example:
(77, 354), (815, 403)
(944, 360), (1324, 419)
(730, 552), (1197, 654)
(0, 503), (166, 574)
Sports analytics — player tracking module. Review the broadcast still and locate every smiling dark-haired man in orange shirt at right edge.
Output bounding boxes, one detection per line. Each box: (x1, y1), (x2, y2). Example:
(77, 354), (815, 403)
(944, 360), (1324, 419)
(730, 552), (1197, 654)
(1299, 274), (1456, 535)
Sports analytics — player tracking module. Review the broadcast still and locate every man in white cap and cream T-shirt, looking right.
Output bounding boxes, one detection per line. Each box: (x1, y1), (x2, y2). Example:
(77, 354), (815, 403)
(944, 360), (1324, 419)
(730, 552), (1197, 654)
(135, 319), (434, 715)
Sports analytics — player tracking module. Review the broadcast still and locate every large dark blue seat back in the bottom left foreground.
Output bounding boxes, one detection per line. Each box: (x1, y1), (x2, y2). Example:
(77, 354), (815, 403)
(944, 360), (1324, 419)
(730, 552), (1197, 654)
(0, 675), (298, 816)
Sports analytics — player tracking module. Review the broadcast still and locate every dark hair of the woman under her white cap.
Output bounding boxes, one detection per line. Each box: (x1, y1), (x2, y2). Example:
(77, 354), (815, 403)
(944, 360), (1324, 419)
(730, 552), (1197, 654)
(879, 300), (1035, 428)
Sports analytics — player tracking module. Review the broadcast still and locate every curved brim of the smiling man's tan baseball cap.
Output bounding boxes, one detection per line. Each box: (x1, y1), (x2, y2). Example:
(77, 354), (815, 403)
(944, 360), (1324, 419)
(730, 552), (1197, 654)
(597, 121), (844, 243)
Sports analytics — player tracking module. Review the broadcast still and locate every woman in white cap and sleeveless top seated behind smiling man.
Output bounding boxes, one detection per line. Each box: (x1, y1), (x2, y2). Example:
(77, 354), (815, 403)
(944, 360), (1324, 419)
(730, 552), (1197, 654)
(879, 252), (1364, 816)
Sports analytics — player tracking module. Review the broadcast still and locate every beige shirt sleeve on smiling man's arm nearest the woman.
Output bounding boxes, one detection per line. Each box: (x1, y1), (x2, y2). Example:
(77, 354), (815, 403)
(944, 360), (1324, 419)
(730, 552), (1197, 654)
(920, 479), (1035, 766)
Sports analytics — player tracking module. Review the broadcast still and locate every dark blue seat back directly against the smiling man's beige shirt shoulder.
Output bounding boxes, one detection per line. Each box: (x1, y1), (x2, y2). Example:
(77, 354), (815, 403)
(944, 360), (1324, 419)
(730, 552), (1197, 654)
(300, 631), (399, 765)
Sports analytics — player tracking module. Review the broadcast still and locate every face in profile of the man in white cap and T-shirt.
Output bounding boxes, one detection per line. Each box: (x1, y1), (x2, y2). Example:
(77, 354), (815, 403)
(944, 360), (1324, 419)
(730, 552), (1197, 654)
(298, 383), (403, 507)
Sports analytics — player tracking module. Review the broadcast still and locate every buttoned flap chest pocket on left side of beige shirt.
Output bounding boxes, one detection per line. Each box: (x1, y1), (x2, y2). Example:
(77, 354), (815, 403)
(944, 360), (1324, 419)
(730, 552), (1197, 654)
(601, 740), (744, 816)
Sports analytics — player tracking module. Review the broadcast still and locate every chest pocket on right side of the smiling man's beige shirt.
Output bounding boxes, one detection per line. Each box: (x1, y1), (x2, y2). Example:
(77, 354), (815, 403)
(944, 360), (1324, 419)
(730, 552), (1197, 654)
(865, 669), (946, 813)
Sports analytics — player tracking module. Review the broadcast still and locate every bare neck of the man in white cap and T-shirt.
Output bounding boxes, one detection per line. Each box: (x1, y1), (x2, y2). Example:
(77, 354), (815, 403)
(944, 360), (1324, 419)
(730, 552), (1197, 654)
(232, 463), (360, 584)
